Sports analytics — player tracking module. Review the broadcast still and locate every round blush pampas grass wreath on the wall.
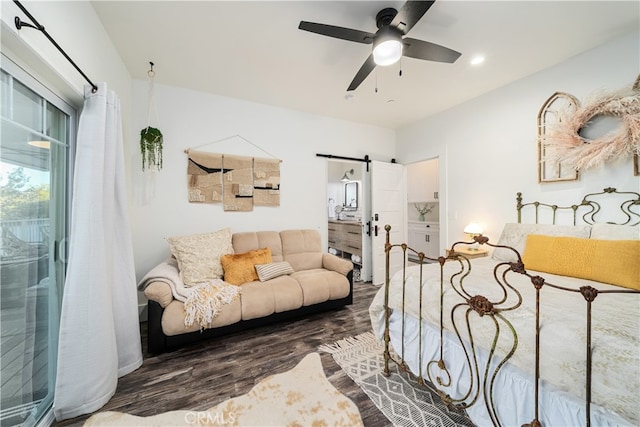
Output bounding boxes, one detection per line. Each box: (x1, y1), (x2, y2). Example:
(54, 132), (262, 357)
(541, 84), (640, 171)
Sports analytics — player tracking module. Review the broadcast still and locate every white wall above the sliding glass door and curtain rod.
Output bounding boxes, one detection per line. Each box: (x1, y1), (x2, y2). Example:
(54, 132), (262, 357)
(0, 1), (135, 139)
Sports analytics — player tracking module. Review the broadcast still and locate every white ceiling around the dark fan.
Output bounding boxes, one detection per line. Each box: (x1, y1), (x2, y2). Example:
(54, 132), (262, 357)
(92, 0), (640, 128)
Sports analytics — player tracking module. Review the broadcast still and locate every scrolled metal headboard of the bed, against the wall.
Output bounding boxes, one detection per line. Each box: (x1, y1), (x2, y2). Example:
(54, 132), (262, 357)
(516, 187), (640, 225)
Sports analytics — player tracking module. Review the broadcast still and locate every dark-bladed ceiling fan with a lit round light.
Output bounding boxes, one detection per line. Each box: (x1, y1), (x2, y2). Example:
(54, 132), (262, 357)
(298, 1), (461, 91)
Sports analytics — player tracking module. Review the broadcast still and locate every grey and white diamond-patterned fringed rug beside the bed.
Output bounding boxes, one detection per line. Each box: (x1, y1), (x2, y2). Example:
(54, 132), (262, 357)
(318, 332), (474, 427)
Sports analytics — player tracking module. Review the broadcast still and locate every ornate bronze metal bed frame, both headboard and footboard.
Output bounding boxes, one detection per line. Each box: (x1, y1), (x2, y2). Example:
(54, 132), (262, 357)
(384, 188), (640, 427)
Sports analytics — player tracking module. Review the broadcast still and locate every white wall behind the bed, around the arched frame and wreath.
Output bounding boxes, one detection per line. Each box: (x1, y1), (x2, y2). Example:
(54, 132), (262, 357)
(397, 32), (640, 251)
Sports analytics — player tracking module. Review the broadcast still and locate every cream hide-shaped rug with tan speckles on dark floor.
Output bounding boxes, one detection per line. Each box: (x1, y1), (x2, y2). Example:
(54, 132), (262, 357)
(84, 353), (363, 427)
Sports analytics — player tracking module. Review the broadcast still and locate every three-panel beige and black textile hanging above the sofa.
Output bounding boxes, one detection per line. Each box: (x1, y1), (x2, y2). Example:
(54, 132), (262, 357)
(185, 135), (281, 212)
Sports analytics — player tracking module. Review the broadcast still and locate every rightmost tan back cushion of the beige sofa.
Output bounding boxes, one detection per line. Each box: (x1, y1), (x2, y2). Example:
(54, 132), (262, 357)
(280, 230), (323, 272)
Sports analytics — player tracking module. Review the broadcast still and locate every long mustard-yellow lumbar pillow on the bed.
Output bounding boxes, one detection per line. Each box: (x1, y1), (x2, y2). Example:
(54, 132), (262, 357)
(522, 234), (640, 290)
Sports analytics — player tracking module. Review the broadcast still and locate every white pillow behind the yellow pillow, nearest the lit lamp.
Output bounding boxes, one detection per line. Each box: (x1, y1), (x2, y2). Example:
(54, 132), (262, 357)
(491, 223), (591, 262)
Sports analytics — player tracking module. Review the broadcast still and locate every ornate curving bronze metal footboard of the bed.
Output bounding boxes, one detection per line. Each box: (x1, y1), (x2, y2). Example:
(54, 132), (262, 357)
(383, 225), (640, 427)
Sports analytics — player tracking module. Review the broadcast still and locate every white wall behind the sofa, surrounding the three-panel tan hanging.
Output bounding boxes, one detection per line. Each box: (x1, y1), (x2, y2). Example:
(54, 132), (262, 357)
(132, 81), (395, 278)
